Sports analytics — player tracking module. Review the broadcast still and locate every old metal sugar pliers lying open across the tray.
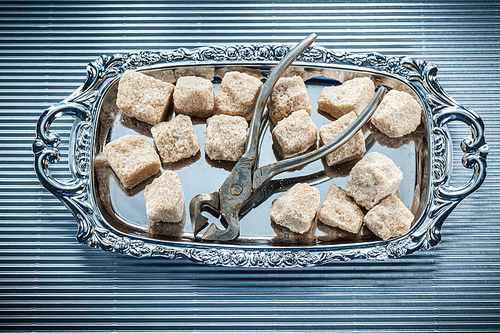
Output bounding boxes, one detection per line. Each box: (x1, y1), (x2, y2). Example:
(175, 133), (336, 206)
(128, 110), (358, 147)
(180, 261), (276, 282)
(189, 34), (386, 241)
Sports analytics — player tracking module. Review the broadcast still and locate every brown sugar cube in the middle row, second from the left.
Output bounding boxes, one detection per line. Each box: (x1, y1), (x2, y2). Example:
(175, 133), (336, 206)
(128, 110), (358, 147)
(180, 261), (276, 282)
(151, 114), (200, 163)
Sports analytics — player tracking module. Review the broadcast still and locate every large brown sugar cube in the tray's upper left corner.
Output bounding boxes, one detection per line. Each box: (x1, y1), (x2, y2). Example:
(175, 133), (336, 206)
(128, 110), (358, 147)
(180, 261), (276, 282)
(116, 71), (174, 125)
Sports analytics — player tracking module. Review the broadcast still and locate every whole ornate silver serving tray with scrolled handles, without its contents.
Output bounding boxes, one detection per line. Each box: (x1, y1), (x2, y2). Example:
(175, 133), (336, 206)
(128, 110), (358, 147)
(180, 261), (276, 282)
(33, 45), (489, 267)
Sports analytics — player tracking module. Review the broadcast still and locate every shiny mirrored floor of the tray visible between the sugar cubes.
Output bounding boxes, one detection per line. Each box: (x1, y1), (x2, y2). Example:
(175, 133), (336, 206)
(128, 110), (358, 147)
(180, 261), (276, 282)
(93, 63), (430, 247)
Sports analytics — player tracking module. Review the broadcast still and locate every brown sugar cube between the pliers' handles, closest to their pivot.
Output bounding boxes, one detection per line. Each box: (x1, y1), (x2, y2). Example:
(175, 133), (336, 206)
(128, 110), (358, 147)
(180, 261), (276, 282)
(273, 110), (318, 157)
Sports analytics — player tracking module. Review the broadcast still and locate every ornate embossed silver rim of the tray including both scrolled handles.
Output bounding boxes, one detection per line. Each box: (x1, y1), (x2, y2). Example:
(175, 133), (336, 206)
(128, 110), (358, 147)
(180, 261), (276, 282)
(33, 44), (489, 268)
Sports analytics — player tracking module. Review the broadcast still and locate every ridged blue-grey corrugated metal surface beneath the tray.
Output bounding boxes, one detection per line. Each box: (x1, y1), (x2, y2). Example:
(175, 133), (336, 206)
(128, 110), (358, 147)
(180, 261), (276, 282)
(0, 0), (500, 332)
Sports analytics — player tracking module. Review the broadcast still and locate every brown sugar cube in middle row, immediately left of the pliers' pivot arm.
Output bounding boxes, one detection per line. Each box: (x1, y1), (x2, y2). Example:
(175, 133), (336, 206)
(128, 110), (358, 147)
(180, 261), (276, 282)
(205, 114), (248, 161)
